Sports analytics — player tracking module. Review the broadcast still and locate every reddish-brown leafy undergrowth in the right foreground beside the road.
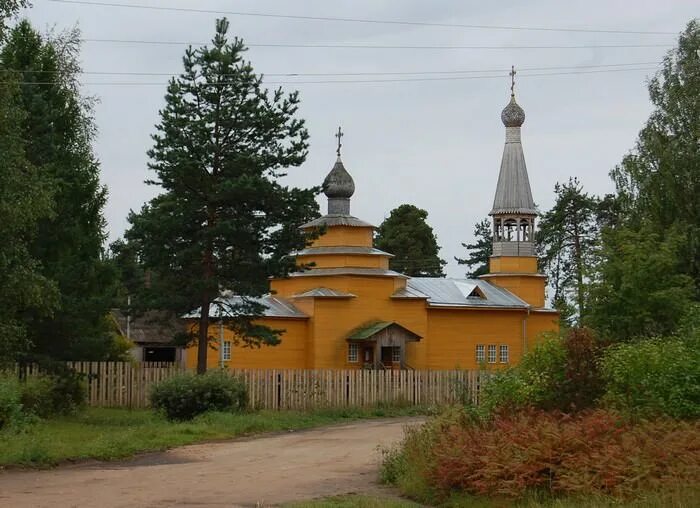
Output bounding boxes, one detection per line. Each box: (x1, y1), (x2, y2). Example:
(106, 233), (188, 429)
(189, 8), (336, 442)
(383, 409), (700, 503)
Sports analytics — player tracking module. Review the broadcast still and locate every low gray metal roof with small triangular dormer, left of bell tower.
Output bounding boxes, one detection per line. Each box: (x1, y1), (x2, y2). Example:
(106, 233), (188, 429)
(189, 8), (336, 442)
(406, 277), (529, 309)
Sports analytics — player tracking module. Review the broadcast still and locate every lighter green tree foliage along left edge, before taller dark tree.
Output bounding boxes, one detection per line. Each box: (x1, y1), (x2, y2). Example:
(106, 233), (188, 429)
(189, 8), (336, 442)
(0, 70), (56, 365)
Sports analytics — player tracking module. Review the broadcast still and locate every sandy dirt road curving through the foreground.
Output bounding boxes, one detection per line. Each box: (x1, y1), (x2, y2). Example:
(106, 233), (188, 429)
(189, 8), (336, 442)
(0, 418), (421, 508)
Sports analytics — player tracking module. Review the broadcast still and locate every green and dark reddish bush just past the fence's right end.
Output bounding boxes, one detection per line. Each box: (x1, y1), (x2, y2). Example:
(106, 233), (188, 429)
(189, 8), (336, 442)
(482, 328), (603, 412)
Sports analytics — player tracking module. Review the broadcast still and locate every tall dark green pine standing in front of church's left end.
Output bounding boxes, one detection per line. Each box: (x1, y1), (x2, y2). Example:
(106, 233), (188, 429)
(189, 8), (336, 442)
(126, 19), (318, 373)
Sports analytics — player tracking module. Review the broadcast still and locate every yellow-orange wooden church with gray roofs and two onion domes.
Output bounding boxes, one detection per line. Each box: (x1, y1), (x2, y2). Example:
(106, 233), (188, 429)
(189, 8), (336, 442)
(185, 88), (559, 370)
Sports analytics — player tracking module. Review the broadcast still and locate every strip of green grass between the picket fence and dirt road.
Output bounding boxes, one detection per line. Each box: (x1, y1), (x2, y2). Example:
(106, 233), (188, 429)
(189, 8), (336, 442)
(0, 407), (424, 468)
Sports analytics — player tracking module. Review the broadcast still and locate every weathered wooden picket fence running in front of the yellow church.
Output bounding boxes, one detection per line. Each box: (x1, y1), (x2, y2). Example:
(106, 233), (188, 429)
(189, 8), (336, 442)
(21, 362), (489, 410)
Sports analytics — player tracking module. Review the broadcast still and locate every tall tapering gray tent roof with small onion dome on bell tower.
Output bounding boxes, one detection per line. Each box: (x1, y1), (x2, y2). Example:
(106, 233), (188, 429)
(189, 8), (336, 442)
(489, 97), (537, 215)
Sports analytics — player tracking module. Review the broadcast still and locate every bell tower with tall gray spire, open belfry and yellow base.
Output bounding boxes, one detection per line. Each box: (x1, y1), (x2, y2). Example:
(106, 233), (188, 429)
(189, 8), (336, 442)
(482, 69), (545, 307)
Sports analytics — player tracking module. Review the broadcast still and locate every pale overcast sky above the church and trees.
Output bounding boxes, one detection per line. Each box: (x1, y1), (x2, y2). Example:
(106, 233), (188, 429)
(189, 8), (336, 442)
(24, 0), (698, 277)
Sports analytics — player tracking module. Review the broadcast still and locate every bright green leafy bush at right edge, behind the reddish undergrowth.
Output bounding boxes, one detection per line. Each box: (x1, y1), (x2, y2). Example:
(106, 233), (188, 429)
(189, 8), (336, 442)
(601, 337), (700, 418)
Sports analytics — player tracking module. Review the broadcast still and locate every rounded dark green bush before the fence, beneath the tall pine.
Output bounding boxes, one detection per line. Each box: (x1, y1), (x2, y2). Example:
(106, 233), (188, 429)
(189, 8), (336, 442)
(151, 371), (248, 420)
